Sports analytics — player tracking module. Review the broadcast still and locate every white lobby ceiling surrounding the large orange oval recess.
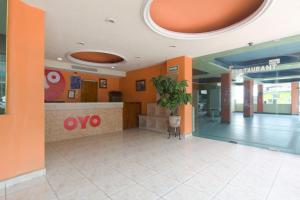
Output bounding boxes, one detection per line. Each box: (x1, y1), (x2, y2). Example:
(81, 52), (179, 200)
(23, 0), (300, 71)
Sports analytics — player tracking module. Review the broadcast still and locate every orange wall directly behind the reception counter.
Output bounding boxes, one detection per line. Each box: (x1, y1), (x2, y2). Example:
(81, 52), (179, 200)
(48, 68), (120, 102)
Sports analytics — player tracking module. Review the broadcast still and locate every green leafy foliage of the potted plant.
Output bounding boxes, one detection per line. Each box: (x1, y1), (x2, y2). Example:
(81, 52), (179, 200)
(152, 76), (192, 116)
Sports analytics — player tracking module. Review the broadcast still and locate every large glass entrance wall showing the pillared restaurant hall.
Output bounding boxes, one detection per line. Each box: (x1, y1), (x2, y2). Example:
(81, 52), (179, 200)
(193, 36), (300, 154)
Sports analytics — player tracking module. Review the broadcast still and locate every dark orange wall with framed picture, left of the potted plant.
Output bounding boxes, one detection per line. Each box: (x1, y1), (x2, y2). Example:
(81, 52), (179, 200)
(120, 63), (166, 114)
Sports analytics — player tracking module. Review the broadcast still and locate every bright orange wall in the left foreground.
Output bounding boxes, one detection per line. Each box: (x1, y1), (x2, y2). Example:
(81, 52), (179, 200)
(0, 0), (45, 180)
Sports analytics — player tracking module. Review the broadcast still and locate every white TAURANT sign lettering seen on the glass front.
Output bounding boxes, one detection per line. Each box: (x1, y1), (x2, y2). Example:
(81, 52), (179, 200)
(231, 59), (280, 74)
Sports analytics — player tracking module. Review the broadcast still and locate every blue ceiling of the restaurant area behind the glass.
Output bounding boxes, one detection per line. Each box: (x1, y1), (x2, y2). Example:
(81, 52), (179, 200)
(193, 35), (300, 83)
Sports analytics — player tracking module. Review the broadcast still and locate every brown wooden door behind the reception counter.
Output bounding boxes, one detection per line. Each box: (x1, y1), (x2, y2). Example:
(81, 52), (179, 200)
(81, 81), (98, 102)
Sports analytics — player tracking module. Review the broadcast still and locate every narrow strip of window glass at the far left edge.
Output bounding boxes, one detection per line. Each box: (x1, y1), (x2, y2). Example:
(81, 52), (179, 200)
(0, 0), (7, 114)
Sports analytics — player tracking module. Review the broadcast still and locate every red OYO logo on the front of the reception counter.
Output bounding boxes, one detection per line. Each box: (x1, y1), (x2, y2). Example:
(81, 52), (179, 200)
(64, 115), (101, 131)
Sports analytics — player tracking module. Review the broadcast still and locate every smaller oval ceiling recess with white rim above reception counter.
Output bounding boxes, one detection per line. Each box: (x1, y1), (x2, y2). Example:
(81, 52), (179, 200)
(67, 50), (126, 67)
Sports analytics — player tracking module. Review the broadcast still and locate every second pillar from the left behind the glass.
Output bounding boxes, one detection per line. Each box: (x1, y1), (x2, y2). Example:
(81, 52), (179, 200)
(244, 80), (254, 117)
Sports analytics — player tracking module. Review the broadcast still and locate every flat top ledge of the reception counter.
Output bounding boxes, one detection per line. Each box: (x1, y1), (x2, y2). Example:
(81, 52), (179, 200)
(45, 102), (123, 110)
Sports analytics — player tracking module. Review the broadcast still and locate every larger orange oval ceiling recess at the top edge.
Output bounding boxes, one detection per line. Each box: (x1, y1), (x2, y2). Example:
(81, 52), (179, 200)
(150, 0), (264, 33)
